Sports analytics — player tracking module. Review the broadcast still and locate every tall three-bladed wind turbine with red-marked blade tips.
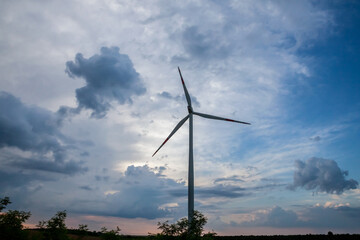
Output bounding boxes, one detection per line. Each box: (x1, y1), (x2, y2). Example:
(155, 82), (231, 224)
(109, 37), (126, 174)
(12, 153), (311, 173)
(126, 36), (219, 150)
(152, 67), (250, 224)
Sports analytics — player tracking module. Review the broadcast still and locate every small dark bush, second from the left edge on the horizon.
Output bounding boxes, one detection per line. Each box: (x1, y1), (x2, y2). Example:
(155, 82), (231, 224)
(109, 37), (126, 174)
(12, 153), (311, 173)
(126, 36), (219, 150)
(37, 210), (69, 240)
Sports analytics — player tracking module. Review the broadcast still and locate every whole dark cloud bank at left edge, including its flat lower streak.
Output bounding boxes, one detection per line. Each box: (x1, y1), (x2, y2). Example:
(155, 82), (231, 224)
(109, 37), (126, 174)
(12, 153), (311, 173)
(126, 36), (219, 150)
(0, 92), (86, 175)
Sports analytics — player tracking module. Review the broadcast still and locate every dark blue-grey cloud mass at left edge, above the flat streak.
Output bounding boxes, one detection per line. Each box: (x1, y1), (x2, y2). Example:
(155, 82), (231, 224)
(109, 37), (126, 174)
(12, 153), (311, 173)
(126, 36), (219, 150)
(0, 92), (65, 158)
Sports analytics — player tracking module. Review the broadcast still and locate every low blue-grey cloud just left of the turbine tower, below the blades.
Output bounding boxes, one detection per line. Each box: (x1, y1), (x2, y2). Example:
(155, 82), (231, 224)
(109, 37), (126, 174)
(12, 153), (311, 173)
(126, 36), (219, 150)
(74, 165), (186, 219)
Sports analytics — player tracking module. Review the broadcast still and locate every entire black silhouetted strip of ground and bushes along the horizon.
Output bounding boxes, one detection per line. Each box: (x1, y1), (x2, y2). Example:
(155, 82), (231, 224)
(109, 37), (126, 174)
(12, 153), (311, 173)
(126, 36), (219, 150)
(0, 197), (360, 240)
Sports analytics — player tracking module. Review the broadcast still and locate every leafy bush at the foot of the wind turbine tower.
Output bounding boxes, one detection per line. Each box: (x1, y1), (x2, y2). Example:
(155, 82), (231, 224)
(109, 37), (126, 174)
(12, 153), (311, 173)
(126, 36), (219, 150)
(153, 211), (216, 239)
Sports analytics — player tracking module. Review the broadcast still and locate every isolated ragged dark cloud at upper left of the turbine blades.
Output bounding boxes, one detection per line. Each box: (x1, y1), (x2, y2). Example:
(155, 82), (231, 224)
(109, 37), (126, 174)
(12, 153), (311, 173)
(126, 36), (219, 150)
(63, 47), (146, 118)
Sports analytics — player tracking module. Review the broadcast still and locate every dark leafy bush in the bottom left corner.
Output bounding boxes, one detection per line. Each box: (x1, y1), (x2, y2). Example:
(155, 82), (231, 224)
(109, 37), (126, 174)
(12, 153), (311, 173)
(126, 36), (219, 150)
(0, 197), (31, 240)
